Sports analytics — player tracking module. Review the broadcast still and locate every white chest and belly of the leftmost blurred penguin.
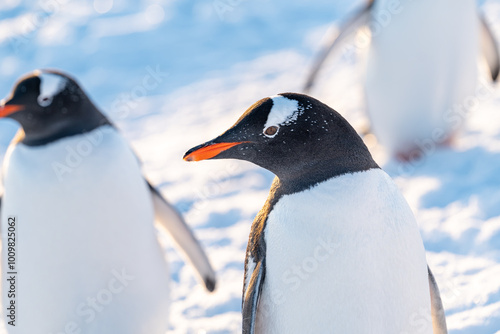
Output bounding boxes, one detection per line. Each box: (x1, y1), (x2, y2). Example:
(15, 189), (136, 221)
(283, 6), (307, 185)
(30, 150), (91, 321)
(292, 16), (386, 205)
(2, 128), (168, 334)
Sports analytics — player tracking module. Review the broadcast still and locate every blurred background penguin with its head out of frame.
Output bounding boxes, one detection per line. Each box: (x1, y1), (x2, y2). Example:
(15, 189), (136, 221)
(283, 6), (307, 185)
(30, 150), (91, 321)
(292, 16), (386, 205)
(304, 0), (499, 160)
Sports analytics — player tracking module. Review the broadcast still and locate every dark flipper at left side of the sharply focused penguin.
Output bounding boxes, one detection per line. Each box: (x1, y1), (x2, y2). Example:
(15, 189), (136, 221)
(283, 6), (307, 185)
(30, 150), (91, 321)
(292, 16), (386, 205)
(242, 260), (264, 334)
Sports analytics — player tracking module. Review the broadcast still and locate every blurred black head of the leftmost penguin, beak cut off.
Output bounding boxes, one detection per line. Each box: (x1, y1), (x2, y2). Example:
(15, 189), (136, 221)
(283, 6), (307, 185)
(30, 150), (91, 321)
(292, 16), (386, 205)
(0, 70), (107, 145)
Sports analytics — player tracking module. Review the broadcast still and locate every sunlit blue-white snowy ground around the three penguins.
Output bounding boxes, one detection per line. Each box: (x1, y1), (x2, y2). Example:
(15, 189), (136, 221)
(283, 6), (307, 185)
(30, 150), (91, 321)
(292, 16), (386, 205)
(0, 0), (500, 334)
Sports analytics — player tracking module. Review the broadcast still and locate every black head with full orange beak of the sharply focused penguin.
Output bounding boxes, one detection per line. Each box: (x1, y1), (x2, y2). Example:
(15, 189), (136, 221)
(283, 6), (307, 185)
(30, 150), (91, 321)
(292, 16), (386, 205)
(184, 93), (378, 183)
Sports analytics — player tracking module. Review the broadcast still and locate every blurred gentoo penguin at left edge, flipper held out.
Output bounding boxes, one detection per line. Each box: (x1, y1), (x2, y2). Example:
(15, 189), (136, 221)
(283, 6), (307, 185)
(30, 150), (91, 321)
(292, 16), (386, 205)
(0, 70), (215, 334)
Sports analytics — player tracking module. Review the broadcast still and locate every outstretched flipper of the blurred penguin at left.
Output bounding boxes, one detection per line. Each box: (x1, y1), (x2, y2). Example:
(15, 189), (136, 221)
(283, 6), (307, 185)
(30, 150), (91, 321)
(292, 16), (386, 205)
(148, 182), (216, 292)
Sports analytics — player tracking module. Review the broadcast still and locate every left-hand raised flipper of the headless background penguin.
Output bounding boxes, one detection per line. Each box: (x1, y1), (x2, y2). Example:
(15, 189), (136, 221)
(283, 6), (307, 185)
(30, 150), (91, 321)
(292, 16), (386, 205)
(303, 0), (374, 94)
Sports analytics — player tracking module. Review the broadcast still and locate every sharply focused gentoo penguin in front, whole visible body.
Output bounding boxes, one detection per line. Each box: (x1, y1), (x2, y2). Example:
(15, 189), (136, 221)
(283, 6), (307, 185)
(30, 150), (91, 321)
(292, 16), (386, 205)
(184, 93), (446, 334)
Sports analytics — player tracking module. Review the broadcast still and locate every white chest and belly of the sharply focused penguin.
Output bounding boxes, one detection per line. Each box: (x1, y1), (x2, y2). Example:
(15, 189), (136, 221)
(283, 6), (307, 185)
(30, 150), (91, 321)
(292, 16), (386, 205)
(258, 170), (430, 333)
